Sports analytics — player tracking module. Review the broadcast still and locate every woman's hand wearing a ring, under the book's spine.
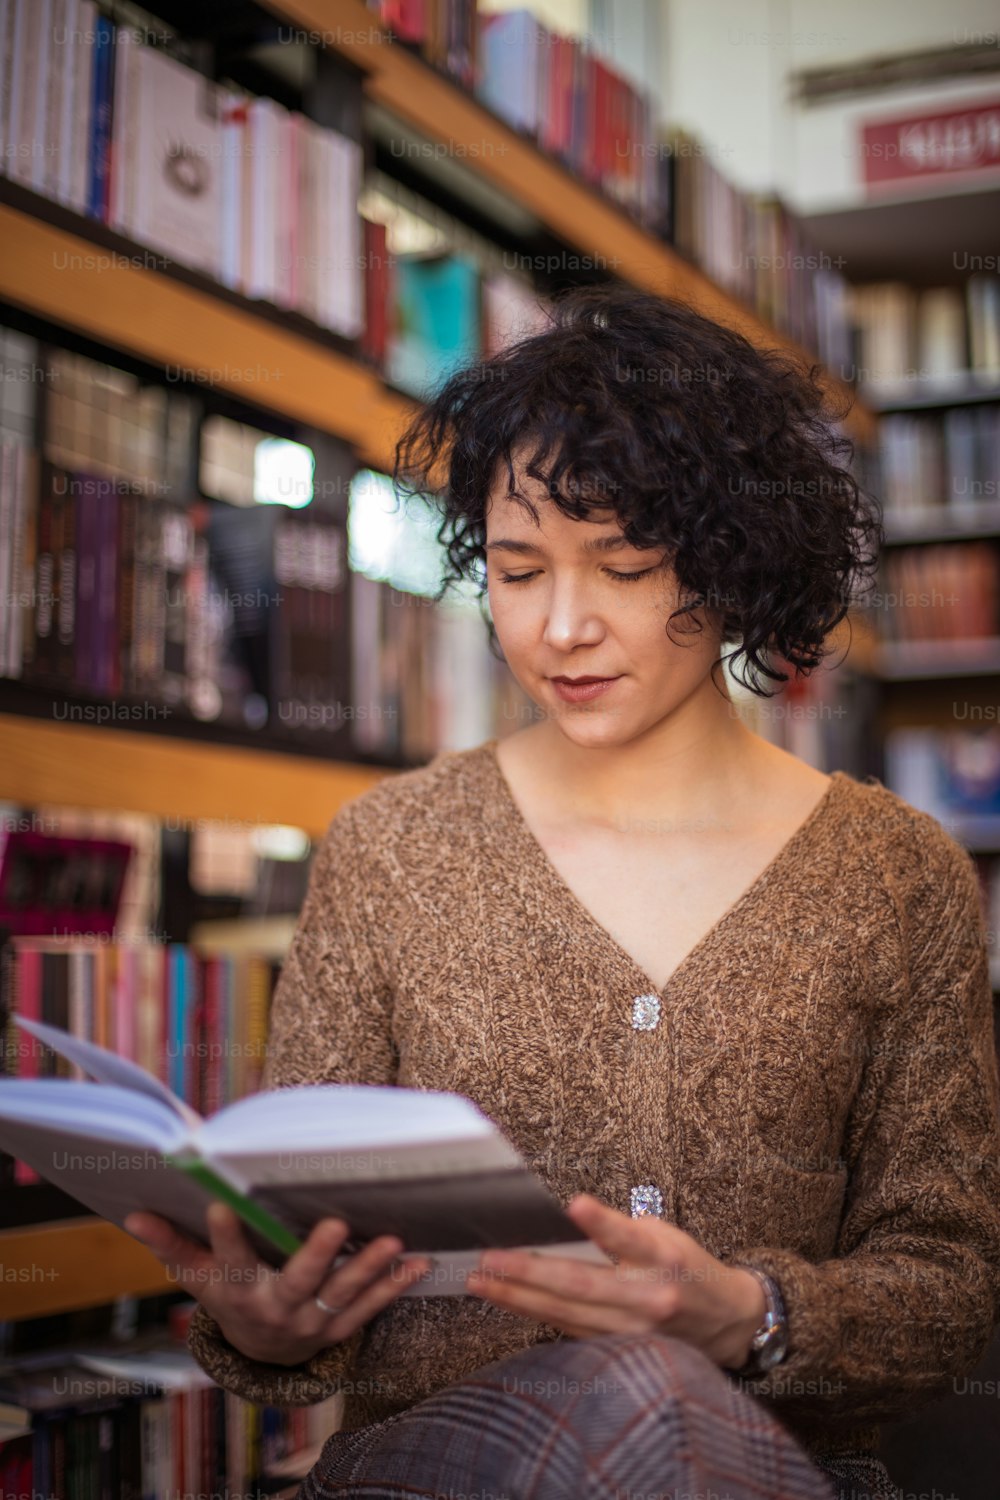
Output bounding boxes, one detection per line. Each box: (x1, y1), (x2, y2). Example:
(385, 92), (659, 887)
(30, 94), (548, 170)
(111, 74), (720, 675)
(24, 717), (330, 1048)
(124, 1203), (432, 1365)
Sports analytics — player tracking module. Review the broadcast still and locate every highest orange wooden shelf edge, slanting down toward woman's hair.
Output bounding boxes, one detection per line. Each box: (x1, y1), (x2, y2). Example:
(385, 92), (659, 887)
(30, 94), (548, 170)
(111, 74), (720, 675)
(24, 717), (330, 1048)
(264, 0), (876, 443)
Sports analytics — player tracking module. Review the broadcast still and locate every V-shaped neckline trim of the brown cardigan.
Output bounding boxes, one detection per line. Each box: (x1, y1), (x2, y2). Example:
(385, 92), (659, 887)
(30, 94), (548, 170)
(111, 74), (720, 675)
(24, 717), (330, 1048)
(483, 737), (849, 999)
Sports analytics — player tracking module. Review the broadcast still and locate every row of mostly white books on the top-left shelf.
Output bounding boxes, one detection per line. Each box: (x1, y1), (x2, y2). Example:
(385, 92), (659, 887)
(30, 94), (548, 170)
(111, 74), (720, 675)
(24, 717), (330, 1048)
(0, 0), (364, 339)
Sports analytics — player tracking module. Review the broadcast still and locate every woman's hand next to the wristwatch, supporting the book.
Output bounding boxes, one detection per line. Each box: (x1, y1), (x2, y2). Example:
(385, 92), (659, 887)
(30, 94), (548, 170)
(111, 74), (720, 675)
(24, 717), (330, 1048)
(466, 1193), (766, 1370)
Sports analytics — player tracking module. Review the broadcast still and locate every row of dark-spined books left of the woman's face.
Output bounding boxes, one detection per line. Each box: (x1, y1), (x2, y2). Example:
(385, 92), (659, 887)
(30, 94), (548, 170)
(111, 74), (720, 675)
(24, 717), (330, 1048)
(0, 444), (532, 761)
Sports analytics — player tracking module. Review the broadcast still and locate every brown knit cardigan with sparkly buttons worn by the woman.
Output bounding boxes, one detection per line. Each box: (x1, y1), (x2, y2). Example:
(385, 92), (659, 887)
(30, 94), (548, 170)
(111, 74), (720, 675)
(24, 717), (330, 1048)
(189, 740), (1000, 1455)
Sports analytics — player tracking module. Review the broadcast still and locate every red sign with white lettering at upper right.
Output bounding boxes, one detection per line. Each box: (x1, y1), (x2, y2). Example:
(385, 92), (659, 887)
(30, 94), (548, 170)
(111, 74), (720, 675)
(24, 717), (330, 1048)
(861, 101), (1000, 188)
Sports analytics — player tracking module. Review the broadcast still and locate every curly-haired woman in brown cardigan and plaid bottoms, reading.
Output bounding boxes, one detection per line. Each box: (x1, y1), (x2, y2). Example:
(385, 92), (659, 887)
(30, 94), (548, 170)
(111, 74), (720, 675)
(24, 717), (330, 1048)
(128, 288), (1000, 1500)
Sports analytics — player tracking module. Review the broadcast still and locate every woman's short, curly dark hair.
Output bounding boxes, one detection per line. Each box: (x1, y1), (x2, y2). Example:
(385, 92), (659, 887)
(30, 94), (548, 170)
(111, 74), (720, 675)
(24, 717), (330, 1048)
(393, 284), (885, 698)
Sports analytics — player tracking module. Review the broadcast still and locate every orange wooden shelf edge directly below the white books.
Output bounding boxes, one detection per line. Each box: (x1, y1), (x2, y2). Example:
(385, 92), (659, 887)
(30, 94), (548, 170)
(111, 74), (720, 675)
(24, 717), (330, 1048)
(0, 203), (414, 473)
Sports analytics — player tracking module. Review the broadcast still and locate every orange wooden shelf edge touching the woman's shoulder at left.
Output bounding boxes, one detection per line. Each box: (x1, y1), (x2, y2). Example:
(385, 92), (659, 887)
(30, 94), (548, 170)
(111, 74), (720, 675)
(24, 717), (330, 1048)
(0, 714), (393, 837)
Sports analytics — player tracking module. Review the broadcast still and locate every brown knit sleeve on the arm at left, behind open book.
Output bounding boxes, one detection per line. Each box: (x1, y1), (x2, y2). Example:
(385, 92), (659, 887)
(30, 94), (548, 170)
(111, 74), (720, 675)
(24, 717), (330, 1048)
(187, 803), (397, 1406)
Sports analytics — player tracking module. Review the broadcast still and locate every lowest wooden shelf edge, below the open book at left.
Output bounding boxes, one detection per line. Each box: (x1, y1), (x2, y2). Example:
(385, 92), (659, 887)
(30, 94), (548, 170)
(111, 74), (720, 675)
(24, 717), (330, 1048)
(0, 1218), (173, 1323)
